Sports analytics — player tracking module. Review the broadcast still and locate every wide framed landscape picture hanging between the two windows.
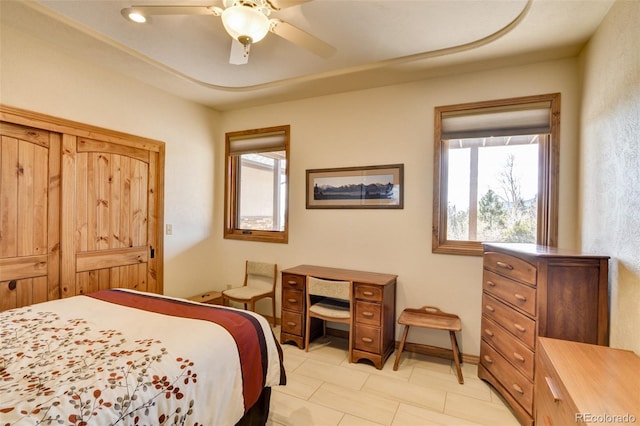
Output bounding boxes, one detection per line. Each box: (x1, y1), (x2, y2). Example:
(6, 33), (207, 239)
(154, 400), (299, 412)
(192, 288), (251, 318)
(306, 164), (404, 209)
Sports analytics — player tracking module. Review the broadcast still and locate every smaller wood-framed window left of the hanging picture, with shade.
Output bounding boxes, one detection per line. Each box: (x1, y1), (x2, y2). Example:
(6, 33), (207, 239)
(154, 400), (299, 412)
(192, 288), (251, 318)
(224, 126), (289, 243)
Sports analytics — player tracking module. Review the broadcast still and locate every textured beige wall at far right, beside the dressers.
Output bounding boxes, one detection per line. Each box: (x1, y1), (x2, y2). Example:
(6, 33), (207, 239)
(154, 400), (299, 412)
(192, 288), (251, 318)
(579, 1), (640, 354)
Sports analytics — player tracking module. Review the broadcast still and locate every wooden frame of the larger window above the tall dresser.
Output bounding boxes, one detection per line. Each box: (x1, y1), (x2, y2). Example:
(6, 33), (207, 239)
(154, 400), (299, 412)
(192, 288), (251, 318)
(431, 93), (560, 256)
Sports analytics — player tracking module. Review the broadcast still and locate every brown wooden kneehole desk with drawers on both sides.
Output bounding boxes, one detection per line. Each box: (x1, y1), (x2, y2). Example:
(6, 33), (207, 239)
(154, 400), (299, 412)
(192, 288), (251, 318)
(280, 265), (397, 370)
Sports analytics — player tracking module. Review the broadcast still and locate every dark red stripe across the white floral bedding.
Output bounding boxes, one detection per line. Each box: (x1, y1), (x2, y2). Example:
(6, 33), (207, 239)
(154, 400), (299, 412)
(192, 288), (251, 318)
(87, 289), (266, 411)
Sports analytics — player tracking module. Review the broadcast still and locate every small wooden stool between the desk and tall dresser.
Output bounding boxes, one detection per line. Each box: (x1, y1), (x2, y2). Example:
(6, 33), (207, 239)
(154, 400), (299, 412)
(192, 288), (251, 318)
(393, 306), (464, 384)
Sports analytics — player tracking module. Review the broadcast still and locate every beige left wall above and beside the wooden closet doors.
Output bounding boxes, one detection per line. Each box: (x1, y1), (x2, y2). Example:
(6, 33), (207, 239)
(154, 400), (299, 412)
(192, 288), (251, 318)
(0, 24), (219, 296)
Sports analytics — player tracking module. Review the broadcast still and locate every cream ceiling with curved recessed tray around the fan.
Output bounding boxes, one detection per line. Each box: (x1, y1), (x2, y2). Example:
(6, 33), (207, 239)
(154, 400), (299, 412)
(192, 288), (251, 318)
(0, 0), (613, 110)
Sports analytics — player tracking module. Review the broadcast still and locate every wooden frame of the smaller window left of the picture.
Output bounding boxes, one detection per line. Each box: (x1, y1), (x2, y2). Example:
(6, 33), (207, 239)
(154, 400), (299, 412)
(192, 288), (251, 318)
(224, 125), (291, 244)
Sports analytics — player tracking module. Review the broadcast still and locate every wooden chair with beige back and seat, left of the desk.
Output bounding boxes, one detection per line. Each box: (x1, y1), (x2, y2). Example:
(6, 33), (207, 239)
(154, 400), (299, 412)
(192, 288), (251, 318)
(222, 260), (278, 327)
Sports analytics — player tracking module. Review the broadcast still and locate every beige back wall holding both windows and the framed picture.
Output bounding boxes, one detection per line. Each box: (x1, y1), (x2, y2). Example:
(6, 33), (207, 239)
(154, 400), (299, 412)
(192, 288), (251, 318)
(214, 60), (579, 354)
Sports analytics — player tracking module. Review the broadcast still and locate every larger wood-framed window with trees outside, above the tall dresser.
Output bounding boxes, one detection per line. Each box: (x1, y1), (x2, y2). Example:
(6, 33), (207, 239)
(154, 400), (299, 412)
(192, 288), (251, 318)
(432, 93), (560, 255)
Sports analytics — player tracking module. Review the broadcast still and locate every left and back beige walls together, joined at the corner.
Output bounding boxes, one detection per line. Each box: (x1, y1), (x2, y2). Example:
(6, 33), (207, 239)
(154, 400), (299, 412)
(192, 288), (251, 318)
(0, 11), (592, 355)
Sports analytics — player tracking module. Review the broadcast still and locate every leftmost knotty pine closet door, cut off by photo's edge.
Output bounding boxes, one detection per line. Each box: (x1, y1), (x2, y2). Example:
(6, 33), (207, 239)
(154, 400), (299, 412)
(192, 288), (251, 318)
(0, 122), (60, 311)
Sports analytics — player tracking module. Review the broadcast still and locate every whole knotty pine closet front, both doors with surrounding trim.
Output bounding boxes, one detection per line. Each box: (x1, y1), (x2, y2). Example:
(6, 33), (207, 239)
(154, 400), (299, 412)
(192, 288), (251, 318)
(0, 105), (164, 311)
